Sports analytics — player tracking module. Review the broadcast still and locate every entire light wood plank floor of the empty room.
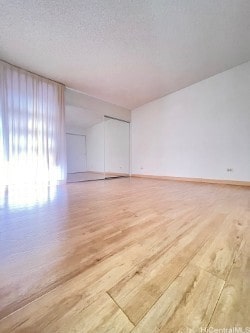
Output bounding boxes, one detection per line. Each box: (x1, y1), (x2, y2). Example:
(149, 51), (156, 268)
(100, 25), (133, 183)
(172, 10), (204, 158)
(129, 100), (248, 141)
(0, 178), (250, 333)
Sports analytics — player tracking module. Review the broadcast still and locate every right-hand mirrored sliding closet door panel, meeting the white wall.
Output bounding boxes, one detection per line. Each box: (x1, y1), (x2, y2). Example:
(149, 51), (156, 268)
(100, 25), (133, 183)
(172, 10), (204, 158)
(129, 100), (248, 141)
(104, 117), (130, 178)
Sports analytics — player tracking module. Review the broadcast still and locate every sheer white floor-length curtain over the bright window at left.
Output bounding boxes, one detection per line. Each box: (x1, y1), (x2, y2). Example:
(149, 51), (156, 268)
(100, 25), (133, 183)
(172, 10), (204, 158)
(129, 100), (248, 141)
(0, 61), (66, 185)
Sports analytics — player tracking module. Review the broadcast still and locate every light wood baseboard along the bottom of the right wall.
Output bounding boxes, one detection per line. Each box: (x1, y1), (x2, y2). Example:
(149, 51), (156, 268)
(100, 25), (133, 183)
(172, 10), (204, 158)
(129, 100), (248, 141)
(131, 174), (250, 186)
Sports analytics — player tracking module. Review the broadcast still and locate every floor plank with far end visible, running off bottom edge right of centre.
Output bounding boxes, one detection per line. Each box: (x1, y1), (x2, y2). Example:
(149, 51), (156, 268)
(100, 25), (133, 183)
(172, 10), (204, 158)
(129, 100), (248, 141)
(133, 265), (225, 333)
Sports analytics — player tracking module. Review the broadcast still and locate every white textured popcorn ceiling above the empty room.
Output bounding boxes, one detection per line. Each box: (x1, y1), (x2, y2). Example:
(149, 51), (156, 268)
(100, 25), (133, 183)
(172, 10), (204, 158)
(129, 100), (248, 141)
(0, 0), (250, 109)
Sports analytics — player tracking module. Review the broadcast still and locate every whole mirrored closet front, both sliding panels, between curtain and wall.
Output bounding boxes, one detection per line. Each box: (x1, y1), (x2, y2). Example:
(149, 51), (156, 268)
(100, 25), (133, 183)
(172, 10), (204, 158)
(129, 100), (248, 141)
(66, 110), (130, 182)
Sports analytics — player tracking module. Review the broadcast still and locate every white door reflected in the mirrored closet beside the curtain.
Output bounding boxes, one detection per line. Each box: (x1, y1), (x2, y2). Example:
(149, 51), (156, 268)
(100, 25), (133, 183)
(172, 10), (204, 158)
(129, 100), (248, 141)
(66, 133), (87, 173)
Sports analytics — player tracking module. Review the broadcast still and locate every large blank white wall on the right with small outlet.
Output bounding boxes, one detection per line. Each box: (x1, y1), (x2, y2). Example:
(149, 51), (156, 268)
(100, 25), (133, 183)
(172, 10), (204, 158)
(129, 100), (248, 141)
(132, 62), (250, 181)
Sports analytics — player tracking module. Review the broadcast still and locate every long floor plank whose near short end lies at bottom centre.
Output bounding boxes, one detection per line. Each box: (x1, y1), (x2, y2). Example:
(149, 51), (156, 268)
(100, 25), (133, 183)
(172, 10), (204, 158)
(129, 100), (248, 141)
(108, 211), (223, 325)
